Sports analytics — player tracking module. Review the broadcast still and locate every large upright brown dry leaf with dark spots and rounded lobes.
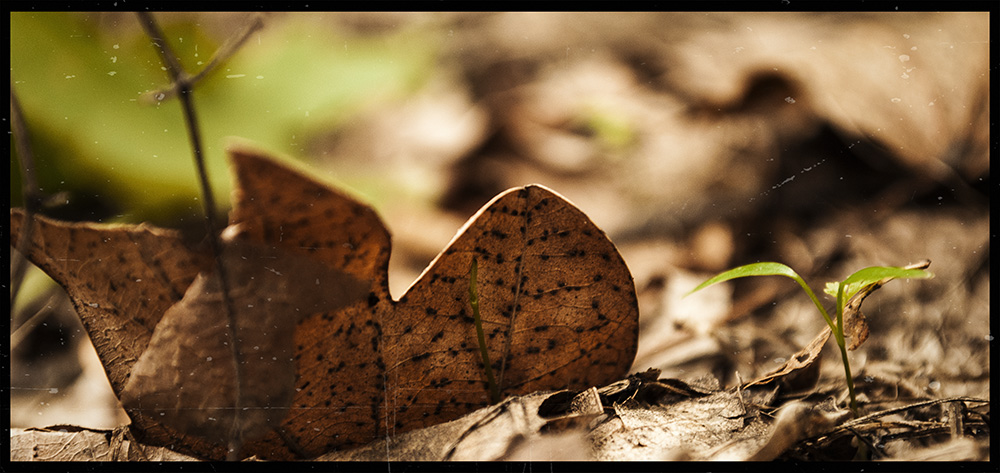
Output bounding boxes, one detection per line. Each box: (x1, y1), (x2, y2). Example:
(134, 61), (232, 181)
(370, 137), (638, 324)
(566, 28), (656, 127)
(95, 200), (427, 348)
(11, 150), (638, 459)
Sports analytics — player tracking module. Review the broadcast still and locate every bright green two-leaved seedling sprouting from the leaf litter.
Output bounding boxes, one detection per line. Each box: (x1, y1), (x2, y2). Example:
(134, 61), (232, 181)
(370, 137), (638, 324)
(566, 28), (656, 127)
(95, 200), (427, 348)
(688, 260), (934, 417)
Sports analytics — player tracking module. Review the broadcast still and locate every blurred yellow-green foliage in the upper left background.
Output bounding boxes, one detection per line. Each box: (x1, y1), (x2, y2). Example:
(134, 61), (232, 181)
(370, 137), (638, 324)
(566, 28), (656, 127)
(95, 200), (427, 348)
(10, 12), (436, 226)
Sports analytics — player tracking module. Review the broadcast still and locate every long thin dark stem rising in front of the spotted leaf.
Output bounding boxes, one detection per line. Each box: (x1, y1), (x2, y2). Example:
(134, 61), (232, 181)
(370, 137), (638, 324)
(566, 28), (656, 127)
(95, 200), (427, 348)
(137, 12), (245, 460)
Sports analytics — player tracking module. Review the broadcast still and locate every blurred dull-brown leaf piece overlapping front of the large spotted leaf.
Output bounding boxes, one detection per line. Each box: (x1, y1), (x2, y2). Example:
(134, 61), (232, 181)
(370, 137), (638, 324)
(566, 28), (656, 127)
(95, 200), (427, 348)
(120, 232), (369, 444)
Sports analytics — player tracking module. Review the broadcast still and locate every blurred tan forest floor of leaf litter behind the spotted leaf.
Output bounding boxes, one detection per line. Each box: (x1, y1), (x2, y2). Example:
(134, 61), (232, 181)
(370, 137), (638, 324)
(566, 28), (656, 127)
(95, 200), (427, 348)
(11, 14), (993, 461)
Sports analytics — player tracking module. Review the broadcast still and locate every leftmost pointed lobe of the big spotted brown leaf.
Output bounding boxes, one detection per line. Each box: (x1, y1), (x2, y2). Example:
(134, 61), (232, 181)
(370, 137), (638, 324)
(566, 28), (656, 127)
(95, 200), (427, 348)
(10, 214), (211, 392)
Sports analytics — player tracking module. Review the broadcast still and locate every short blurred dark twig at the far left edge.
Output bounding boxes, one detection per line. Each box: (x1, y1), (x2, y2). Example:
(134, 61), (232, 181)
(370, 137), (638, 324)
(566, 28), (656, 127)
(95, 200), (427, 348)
(10, 83), (42, 316)
